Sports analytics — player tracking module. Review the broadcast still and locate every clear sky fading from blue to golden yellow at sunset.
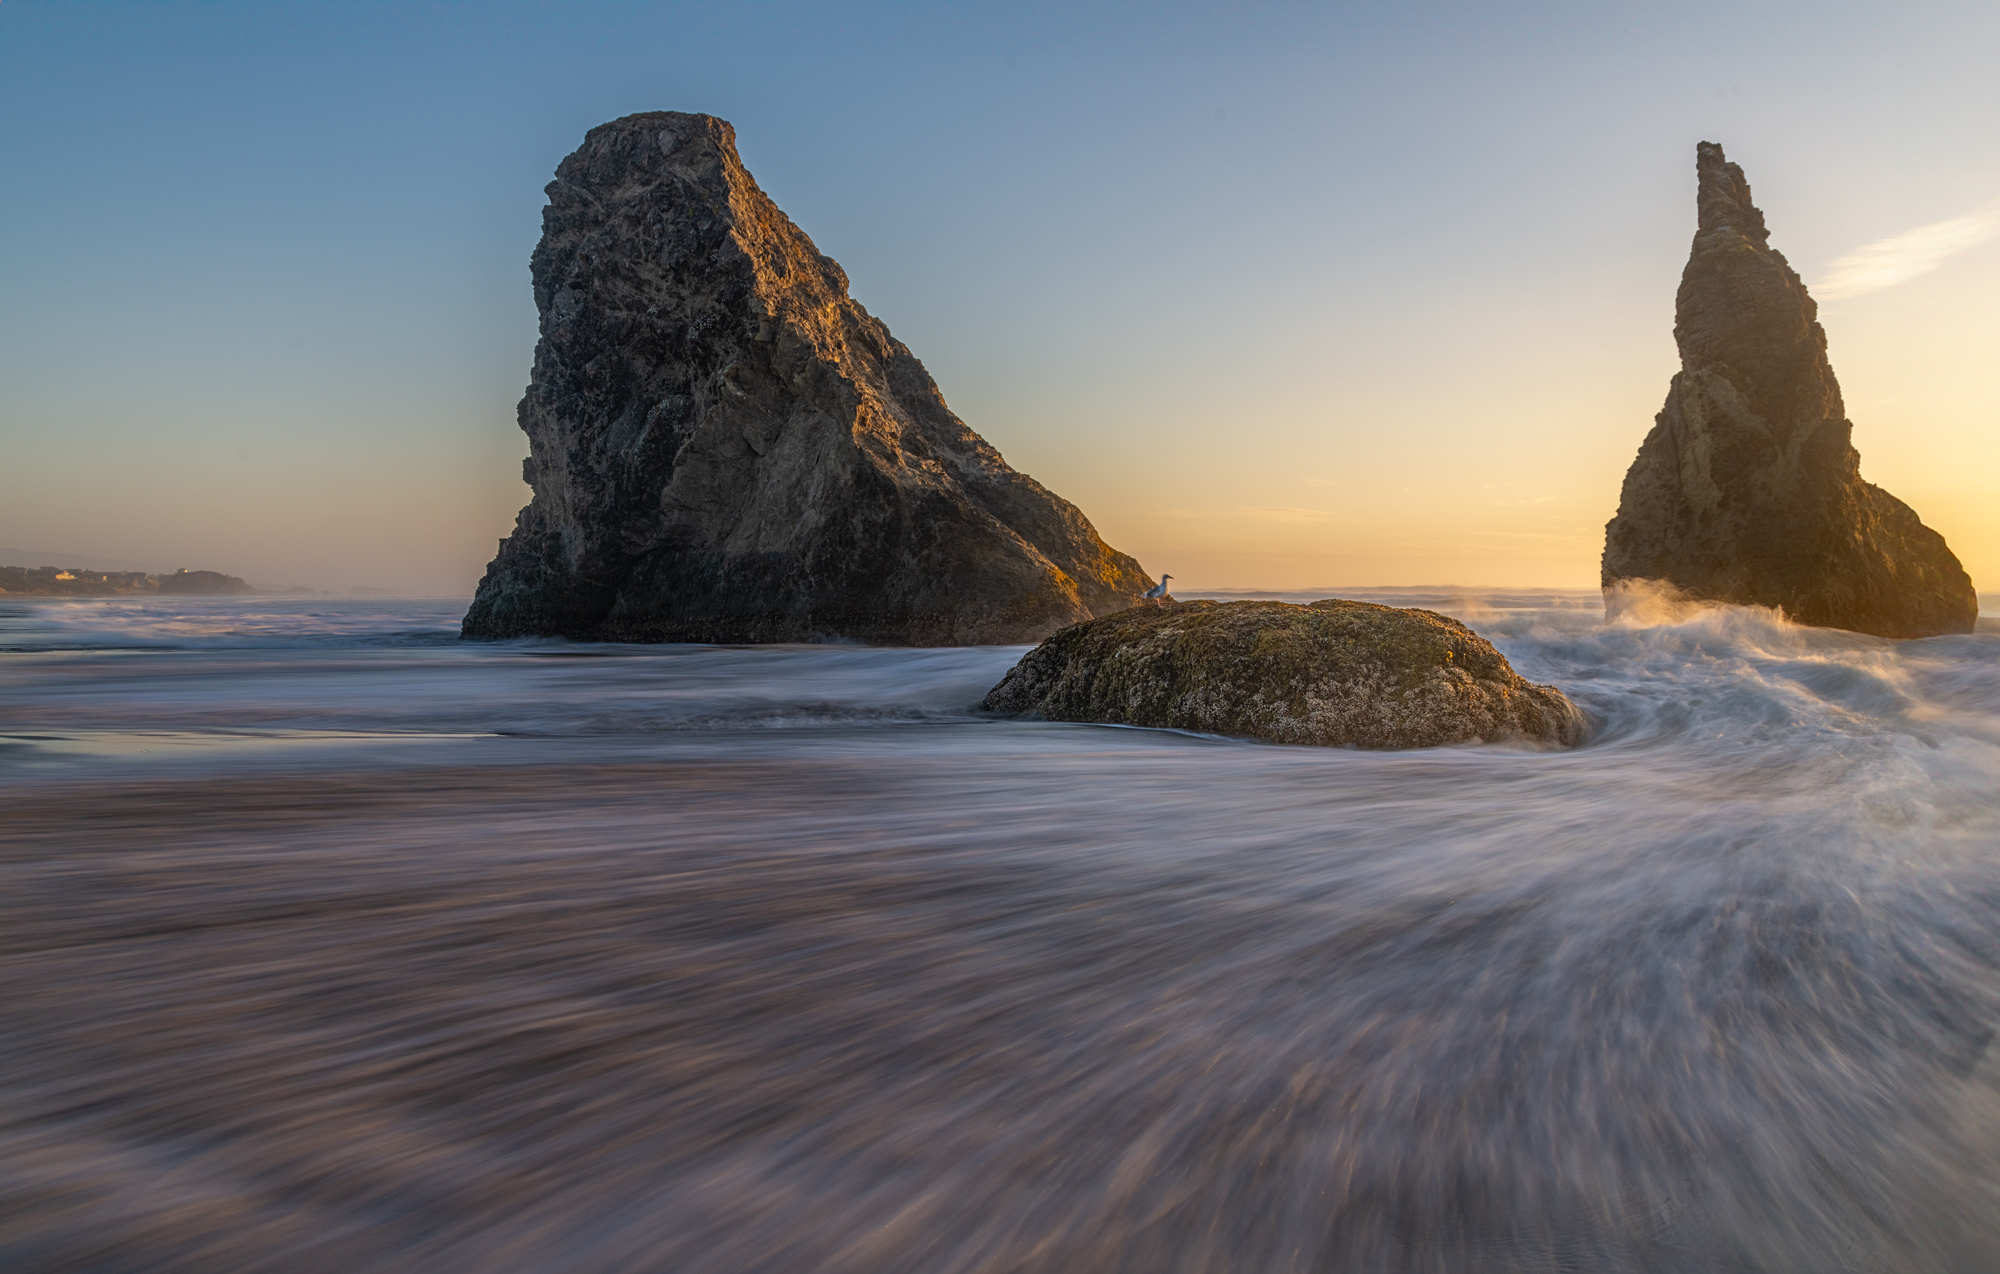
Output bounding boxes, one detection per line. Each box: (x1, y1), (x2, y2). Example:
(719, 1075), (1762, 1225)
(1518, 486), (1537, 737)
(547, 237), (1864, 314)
(0, 0), (2000, 596)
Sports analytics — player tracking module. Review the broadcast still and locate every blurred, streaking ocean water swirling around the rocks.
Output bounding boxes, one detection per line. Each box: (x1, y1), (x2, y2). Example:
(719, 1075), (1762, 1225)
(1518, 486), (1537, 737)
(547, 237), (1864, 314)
(0, 592), (2000, 1274)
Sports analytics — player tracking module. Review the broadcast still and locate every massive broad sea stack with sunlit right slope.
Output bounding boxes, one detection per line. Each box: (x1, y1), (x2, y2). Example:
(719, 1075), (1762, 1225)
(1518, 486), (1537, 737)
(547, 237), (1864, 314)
(462, 112), (1150, 644)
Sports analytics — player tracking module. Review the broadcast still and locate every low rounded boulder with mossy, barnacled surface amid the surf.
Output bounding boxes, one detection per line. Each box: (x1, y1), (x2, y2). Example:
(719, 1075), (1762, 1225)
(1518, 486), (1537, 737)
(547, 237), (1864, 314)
(982, 598), (1584, 748)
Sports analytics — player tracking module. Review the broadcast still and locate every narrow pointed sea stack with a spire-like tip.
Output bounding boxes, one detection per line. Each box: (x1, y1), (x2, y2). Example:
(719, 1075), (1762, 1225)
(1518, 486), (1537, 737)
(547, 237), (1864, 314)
(1604, 142), (1978, 638)
